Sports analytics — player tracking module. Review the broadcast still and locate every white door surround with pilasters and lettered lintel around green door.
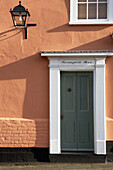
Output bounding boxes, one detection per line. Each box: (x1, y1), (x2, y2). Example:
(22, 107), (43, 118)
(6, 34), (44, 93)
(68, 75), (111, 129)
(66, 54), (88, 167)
(41, 50), (113, 155)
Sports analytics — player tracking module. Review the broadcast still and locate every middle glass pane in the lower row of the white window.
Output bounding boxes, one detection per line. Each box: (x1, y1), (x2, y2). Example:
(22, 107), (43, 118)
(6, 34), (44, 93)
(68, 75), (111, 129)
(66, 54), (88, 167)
(88, 4), (97, 19)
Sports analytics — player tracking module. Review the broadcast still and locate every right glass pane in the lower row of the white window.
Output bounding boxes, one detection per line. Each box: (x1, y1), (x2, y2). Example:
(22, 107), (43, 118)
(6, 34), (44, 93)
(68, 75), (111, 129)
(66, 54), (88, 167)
(98, 3), (107, 19)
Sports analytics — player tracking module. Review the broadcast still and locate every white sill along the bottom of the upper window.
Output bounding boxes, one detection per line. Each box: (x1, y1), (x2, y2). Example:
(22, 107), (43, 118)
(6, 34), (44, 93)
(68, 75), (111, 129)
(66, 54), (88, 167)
(69, 21), (113, 25)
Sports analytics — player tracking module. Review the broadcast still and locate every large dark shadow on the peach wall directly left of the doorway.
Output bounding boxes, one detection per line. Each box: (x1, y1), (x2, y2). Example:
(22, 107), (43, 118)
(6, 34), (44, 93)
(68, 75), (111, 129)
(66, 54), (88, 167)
(0, 53), (49, 119)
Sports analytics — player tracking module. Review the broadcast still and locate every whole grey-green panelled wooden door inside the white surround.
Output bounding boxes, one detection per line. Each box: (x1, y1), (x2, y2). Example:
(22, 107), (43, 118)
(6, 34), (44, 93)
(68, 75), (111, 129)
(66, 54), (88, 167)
(61, 72), (93, 151)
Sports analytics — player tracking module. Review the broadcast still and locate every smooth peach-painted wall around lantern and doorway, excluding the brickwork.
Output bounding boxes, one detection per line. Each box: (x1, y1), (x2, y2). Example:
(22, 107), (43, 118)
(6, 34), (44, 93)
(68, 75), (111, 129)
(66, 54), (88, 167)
(0, 0), (113, 147)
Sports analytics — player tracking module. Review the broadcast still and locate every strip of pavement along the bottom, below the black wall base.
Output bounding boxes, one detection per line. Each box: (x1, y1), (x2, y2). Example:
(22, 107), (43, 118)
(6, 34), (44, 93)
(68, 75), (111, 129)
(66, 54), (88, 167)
(0, 163), (113, 170)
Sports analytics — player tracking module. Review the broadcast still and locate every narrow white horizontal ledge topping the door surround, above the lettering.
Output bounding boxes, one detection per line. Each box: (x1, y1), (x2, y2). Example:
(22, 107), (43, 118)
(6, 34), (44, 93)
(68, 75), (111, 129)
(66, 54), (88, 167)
(41, 53), (113, 57)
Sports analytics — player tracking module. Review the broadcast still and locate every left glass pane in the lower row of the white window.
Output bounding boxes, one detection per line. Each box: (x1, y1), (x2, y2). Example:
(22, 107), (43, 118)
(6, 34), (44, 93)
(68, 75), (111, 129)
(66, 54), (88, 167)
(78, 4), (87, 19)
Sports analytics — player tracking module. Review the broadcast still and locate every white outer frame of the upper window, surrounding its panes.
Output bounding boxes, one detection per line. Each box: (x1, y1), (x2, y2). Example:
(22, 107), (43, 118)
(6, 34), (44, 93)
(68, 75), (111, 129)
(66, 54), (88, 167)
(69, 0), (113, 25)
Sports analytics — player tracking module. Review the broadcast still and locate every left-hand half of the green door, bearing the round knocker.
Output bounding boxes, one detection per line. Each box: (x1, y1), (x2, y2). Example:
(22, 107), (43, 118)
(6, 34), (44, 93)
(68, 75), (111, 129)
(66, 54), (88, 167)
(61, 73), (77, 150)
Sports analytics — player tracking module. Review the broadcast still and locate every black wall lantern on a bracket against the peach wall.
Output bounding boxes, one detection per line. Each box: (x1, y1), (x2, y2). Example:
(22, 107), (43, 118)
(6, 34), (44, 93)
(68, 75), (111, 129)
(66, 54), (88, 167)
(10, 1), (36, 39)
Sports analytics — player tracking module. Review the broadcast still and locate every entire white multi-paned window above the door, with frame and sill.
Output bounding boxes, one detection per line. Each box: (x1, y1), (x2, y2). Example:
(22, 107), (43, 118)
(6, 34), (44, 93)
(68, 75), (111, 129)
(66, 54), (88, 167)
(70, 0), (113, 24)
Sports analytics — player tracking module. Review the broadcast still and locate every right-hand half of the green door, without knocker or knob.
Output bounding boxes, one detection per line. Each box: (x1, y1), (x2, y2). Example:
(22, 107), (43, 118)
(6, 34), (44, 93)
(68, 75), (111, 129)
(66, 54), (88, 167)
(76, 72), (93, 150)
